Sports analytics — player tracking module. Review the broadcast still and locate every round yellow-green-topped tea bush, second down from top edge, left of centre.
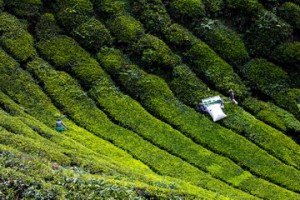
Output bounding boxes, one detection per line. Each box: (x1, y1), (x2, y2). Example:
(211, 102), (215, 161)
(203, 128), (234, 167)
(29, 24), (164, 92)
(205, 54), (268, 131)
(108, 15), (145, 44)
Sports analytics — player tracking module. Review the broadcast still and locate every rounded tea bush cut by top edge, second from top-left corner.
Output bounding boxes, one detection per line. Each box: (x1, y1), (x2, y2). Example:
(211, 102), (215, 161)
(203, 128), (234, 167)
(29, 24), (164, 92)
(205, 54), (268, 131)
(55, 0), (94, 31)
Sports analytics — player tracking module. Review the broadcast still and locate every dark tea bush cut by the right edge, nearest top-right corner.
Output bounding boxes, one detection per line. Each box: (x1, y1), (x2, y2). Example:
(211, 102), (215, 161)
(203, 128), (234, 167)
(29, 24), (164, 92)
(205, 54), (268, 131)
(279, 2), (300, 30)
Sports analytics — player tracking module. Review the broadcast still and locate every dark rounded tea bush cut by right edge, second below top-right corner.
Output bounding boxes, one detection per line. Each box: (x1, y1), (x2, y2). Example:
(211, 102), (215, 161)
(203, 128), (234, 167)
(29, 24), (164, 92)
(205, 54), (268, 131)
(272, 42), (300, 70)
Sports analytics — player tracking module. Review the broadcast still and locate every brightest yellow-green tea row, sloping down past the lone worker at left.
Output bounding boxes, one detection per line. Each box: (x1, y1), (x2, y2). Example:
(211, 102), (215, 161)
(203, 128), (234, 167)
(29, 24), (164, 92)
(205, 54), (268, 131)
(0, 93), (223, 200)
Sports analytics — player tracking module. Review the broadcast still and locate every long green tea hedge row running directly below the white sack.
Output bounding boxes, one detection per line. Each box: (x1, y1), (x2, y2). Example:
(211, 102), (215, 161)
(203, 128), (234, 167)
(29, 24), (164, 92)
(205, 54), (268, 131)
(95, 47), (297, 194)
